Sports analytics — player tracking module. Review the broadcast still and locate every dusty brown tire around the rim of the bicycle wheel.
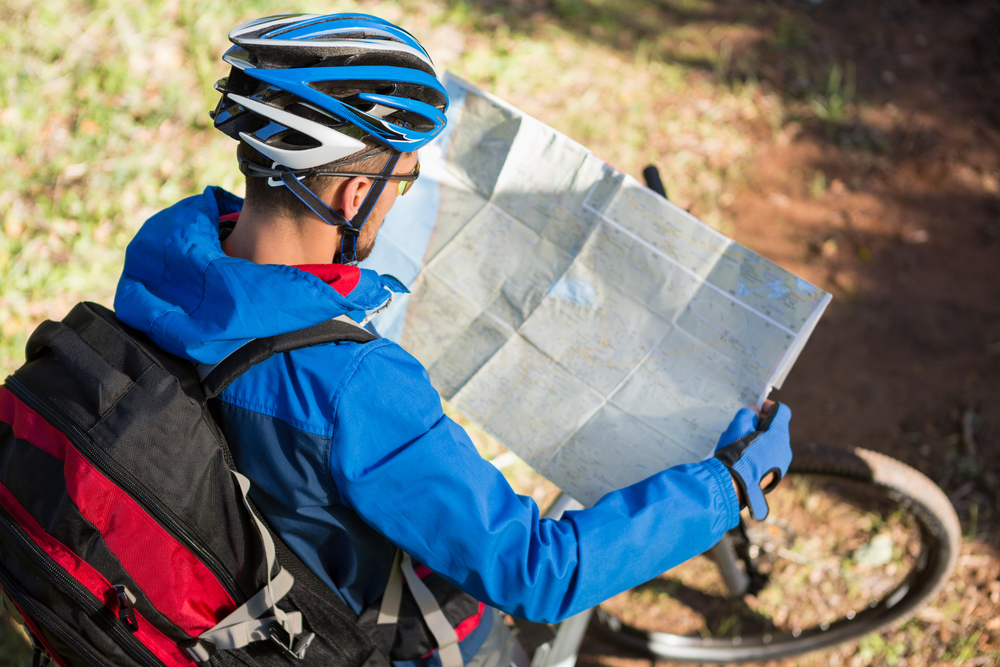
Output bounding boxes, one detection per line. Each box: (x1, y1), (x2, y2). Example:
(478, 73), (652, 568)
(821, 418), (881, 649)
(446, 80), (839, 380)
(595, 444), (961, 663)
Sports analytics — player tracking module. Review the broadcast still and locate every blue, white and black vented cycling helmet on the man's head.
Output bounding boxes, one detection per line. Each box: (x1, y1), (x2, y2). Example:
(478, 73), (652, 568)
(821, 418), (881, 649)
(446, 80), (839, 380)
(212, 14), (448, 173)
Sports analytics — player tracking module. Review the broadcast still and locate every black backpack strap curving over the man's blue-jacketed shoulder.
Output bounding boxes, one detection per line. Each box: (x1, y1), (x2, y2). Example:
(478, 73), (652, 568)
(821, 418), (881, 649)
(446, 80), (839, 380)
(201, 315), (378, 398)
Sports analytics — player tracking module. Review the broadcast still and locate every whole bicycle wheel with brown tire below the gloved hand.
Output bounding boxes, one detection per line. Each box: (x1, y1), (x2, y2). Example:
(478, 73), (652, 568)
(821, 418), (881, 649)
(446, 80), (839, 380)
(595, 445), (961, 662)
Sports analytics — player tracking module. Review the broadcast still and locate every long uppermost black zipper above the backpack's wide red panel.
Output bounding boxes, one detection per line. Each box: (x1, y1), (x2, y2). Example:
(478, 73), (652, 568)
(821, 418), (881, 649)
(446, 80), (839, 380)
(5, 376), (247, 607)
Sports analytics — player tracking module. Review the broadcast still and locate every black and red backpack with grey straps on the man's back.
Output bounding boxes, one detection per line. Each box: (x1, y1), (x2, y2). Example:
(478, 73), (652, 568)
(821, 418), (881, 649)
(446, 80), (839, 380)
(0, 302), (394, 667)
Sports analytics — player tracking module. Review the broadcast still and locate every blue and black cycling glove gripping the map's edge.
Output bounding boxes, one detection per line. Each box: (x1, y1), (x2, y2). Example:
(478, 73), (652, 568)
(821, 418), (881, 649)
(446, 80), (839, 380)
(715, 403), (792, 521)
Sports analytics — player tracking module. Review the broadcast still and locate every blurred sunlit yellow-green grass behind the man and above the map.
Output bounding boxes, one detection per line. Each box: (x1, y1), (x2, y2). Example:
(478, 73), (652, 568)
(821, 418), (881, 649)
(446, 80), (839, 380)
(0, 0), (1000, 666)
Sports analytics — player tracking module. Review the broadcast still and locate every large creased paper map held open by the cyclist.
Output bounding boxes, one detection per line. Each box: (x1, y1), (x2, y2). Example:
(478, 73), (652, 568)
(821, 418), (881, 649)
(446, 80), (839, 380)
(366, 75), (830, 506)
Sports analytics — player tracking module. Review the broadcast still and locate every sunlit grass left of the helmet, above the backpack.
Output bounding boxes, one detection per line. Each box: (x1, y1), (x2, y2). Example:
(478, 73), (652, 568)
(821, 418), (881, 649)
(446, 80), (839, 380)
(0, 0), (250, 371)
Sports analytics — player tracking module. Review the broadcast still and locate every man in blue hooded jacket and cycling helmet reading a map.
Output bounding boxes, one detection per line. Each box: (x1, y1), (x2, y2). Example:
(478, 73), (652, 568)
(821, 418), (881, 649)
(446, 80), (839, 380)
(115, 14), (791, 667)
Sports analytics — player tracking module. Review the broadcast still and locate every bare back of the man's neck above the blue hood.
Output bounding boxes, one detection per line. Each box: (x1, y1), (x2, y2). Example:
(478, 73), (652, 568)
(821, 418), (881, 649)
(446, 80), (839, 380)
(222, 206), (340, 266)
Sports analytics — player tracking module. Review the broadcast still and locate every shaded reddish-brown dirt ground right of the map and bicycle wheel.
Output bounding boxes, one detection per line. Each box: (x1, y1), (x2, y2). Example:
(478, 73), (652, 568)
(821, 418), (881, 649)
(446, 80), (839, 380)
(568, 1), (1000, 667)
